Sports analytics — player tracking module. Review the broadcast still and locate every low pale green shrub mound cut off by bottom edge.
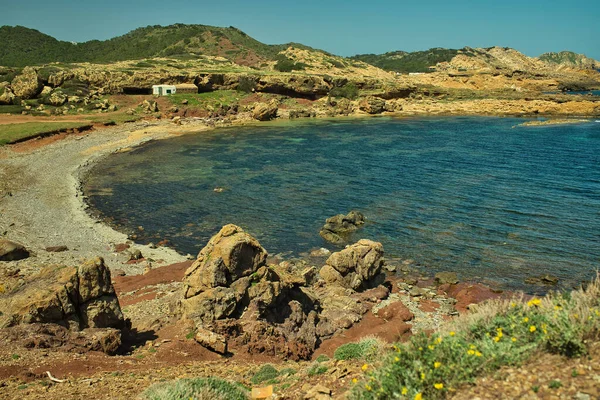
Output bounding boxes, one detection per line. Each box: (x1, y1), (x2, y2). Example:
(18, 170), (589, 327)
(141, 377), (249, 400)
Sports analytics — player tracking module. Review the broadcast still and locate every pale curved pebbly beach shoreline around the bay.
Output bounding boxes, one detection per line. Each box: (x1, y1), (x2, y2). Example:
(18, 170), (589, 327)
(0, 112), (593, 275)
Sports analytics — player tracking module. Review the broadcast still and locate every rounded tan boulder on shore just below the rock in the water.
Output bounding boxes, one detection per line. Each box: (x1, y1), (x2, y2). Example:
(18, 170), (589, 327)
(319, 239), (384, 290)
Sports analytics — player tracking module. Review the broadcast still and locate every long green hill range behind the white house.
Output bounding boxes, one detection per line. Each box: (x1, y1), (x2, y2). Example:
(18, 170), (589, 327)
(0, 24), (324, 66)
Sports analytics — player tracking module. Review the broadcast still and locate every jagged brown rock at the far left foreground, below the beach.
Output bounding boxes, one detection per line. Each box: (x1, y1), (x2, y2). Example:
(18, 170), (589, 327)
(0, 258), (124, 330)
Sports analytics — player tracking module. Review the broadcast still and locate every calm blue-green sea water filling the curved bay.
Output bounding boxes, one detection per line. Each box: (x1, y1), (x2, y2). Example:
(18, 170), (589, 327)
(85, 117), (600, 289)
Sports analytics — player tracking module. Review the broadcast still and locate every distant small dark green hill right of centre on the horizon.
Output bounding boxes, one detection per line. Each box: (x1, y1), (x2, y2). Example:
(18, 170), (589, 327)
(350, 47), (459, 73)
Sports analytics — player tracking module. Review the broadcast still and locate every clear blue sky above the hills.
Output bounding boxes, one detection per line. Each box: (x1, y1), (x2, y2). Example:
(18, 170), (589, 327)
(0, 0), (600, 59)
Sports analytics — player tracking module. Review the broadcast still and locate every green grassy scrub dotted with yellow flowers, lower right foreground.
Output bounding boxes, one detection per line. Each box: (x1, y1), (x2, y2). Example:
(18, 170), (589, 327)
(350, 277), (600, 399)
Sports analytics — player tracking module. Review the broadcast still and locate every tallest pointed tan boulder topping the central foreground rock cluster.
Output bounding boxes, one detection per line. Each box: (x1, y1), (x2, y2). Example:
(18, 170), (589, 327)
(183, 224), (267, 299)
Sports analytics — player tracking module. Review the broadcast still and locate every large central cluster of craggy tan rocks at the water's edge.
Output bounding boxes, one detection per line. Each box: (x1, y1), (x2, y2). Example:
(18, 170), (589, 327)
(179, 225), (388, 360)
